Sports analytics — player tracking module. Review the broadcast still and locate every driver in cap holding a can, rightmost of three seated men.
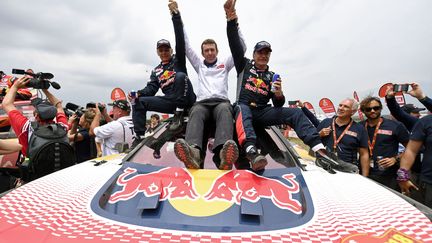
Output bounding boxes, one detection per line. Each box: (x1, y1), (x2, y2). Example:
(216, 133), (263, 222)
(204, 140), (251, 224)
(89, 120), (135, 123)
(224, 0), (325, 171)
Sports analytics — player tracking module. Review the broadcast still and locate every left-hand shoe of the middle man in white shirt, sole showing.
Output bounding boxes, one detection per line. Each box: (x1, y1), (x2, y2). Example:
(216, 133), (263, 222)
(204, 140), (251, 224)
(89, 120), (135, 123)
(174, 138), (202, 169)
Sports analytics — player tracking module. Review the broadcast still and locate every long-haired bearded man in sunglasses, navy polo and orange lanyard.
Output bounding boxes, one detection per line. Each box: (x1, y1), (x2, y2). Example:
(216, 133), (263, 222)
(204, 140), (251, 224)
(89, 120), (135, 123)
(360, 96), (409, 190)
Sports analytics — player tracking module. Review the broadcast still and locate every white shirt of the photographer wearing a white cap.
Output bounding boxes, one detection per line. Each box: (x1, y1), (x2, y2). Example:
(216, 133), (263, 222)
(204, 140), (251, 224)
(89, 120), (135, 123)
(94, 116), (134, 156)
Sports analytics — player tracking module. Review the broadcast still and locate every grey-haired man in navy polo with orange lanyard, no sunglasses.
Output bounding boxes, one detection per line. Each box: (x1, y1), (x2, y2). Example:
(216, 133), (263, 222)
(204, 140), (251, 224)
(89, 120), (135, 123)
(317, 99), (369, 176)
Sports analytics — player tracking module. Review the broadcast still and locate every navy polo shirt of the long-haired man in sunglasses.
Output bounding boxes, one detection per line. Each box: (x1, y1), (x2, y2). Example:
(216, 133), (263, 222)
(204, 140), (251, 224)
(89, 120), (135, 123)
(360, 118), (409, 175)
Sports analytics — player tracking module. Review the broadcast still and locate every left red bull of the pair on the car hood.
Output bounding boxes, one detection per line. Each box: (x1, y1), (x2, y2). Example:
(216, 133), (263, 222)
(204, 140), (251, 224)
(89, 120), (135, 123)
(108, 167), (199, 203)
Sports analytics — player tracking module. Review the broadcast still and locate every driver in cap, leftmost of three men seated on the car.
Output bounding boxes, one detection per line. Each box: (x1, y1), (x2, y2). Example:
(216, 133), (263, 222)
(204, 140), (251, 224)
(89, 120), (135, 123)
(129, 9), (196, 147)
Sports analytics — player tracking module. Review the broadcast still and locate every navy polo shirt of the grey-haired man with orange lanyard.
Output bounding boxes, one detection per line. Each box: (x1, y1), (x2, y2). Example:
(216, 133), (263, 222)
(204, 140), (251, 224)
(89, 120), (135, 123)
(317, 118), (368, 165)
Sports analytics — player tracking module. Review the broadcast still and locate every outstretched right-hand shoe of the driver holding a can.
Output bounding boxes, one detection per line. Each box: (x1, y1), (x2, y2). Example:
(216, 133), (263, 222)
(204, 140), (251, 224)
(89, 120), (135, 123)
(315, 149), (359, 174)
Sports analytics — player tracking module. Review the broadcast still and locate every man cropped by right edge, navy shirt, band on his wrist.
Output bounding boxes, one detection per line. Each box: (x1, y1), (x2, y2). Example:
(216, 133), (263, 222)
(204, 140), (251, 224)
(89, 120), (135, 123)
(397, 115), (432, 207)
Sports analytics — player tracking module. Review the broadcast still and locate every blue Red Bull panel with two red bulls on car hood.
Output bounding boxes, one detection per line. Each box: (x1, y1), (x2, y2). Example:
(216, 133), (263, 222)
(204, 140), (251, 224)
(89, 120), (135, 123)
(91, 162), (314, 232)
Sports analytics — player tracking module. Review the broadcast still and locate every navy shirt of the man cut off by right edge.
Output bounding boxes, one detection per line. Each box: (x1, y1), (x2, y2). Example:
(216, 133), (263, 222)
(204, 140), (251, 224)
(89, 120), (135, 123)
(410, 115), (432, 184)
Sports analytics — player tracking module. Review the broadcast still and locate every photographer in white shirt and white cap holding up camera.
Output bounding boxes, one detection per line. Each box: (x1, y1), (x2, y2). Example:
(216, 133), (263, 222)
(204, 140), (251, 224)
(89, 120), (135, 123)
(90, 100), (134, 156)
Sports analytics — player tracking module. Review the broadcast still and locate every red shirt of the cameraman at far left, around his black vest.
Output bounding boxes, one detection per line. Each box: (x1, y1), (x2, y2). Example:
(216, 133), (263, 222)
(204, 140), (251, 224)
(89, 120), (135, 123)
(8, 110), (69, 156)
